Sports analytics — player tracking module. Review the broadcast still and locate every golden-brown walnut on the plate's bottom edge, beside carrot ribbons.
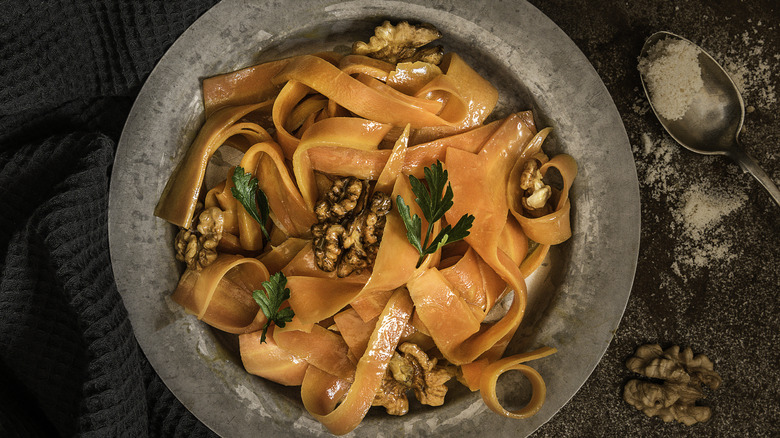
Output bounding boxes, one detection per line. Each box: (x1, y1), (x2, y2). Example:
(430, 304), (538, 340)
(373, 342), (455, 415)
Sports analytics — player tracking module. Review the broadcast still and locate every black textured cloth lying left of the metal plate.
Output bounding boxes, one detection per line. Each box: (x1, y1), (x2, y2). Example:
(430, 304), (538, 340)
(0, 0), (216, 437)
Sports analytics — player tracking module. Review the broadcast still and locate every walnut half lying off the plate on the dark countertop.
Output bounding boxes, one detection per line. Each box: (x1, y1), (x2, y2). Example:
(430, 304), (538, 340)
(623, 344), (721, 426)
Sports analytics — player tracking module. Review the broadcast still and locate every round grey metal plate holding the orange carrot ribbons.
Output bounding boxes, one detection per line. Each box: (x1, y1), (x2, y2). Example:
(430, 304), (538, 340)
(109, 0), (640, 437)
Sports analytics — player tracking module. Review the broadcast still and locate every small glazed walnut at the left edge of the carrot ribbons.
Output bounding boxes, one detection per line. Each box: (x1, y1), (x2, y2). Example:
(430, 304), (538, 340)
(174, 207), (225, 271)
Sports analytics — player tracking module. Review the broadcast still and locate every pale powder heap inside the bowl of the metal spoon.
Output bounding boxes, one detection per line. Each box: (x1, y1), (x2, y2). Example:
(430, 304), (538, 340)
(639, 38), (704, 120)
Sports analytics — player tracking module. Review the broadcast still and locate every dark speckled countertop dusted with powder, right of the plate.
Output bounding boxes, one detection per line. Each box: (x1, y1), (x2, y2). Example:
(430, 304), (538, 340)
(531, 0), (780, 437)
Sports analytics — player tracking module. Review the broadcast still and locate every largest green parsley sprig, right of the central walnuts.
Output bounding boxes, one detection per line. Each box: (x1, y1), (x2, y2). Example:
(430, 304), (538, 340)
(396, 160), (474, 268)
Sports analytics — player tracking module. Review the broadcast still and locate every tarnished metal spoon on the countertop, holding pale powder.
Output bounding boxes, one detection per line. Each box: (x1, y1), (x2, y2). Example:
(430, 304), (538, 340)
(640, 31), (780, 206)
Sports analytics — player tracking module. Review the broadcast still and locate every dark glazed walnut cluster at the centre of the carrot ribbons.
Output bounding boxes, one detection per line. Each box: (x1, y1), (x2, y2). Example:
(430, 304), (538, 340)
(312, 177), (392, 277)
